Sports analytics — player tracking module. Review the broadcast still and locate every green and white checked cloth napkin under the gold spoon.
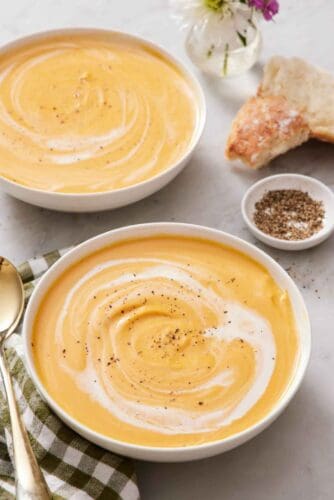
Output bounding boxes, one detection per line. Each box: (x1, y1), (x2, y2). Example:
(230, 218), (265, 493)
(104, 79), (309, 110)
(0, 249), (139, 500)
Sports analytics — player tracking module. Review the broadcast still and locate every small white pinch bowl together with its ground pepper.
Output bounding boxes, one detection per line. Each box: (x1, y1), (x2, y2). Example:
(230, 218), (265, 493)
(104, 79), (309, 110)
(241, 174), (334, 251)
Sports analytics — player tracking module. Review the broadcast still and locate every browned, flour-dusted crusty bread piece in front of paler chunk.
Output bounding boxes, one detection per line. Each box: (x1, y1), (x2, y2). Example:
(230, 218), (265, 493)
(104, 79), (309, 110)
(226, 96), (310, 168)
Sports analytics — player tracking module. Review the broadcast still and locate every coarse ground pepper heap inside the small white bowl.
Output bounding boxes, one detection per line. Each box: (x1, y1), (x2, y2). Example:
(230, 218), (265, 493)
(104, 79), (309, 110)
(253, 189), (325, 241)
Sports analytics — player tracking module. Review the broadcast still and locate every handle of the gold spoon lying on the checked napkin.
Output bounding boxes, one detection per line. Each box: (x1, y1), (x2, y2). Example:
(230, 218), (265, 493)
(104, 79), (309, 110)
(0, 346), (51, 500)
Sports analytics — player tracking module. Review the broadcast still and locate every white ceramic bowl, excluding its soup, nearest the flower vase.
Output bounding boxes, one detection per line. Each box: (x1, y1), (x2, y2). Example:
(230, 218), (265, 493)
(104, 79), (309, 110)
(0, 28), (206, 212)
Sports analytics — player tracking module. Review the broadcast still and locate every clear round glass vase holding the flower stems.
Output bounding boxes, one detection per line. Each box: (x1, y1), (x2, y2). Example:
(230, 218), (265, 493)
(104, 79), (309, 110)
(186, 4), (262, 78)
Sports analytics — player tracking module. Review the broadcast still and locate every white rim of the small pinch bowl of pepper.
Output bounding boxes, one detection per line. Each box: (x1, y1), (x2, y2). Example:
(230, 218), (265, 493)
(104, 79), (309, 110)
(241, 173), (334, 250)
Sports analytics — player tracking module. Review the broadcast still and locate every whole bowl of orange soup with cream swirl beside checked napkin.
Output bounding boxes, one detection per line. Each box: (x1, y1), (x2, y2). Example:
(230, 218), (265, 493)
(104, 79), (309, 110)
(23, 223), (310, 461)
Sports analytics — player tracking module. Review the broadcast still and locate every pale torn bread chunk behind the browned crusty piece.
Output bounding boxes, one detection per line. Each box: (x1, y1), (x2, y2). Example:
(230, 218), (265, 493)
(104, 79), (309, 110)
(258, 57), (334, 142)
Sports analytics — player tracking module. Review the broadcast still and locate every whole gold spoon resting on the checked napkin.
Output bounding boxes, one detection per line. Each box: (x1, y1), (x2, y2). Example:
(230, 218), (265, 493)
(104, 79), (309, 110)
(0, 257), (51, 500)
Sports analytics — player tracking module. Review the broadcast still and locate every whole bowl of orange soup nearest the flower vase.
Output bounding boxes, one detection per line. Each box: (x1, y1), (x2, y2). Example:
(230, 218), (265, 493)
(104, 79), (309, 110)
(0, 29), (205, 212)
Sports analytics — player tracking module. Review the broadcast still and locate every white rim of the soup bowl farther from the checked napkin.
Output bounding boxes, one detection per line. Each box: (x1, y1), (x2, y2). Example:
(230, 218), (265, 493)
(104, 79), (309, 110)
(0, 27), (207, 201)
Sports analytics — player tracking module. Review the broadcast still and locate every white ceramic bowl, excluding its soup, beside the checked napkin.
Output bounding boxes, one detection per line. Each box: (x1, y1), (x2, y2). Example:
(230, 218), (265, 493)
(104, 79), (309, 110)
(23, 223), (311, 462)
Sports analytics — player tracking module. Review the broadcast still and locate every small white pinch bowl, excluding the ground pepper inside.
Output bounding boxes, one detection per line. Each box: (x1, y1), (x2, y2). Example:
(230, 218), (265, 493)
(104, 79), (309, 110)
(241, 174), (334, 251)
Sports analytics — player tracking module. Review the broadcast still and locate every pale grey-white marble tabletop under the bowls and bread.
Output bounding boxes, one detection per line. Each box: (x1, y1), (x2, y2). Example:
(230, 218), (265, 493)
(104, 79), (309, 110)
(0, 0), (334, 500)
